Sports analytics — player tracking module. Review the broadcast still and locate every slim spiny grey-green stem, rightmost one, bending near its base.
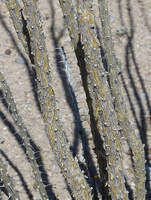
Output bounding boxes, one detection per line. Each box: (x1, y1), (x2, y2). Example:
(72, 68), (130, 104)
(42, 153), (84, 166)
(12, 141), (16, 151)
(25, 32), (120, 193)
(98, 0), (145, 200)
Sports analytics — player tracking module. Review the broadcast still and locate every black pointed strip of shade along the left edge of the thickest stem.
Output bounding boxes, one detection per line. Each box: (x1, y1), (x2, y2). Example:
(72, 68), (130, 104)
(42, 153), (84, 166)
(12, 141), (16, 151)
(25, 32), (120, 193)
(75, 36), (111, 200)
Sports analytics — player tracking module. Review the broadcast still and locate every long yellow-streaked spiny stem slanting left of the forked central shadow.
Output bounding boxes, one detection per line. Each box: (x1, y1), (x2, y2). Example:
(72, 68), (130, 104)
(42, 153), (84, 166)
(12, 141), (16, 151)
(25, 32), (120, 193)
(4, 0), (91, 200)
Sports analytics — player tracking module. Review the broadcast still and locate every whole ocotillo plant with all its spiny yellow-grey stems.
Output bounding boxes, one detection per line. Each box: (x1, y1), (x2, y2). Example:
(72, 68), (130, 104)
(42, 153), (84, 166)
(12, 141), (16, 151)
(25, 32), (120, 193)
(0, 0), (145, 200)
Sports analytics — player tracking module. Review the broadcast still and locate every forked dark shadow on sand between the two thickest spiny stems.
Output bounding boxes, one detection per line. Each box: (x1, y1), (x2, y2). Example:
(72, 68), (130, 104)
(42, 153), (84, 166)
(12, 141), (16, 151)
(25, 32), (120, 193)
(49, 0), (102, 200)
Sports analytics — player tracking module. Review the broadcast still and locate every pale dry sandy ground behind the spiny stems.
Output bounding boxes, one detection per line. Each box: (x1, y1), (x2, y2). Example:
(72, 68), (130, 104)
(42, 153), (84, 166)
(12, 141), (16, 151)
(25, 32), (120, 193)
(0, 0), (151, 200)
